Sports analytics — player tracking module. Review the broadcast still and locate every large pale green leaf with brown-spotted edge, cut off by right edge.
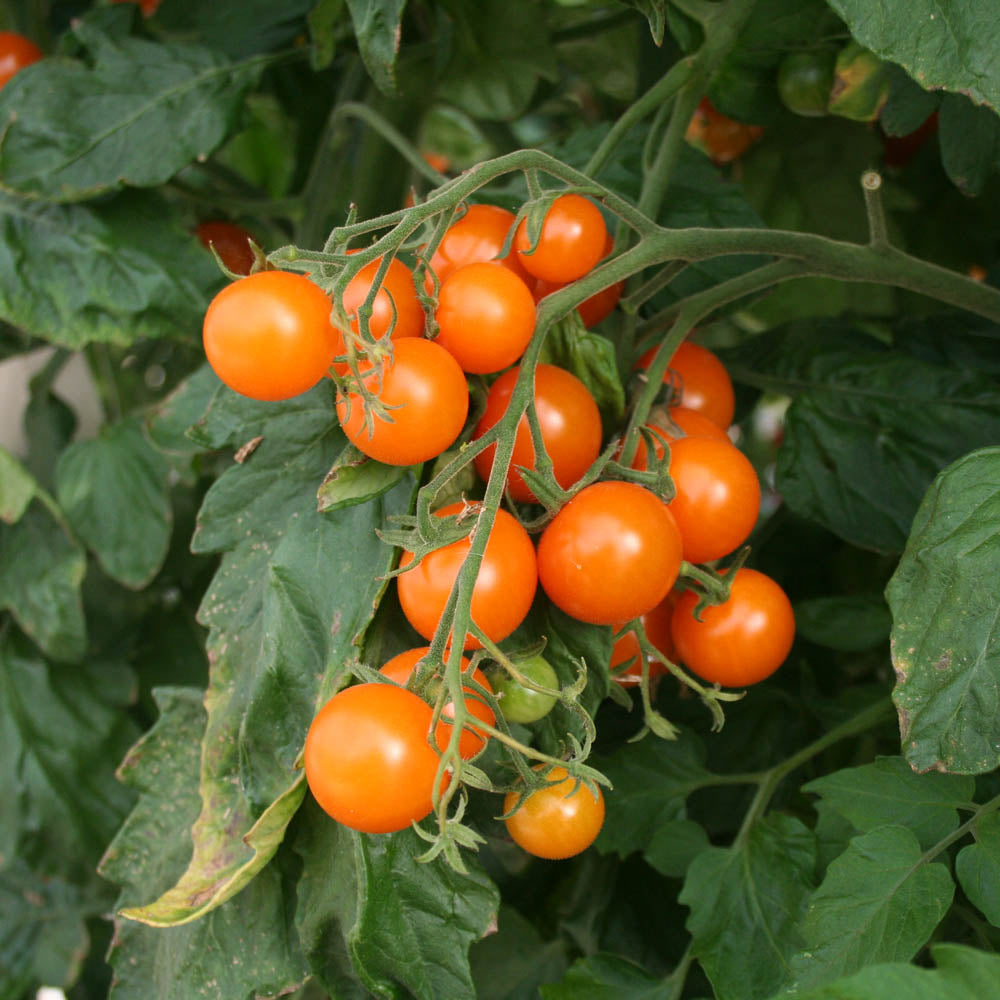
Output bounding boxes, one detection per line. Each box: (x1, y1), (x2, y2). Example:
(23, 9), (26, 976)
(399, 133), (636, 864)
(886, 448), (1000, 774)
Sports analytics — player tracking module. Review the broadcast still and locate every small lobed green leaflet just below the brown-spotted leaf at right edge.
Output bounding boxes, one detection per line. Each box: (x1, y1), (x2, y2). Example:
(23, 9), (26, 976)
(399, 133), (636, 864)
(802, 757), (976, 850)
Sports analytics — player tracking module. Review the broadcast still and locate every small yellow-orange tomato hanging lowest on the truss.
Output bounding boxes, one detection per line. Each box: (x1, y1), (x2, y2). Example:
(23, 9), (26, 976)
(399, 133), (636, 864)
(504, 767), (604, 860)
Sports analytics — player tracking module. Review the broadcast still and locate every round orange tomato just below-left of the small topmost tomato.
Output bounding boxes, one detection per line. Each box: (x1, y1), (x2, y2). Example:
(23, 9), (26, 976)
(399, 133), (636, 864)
(434, 261), (535, 375)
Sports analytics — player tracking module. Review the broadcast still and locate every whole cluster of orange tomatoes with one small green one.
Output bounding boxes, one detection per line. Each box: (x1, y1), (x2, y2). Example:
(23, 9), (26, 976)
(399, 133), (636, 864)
(198, 194), (794, 858)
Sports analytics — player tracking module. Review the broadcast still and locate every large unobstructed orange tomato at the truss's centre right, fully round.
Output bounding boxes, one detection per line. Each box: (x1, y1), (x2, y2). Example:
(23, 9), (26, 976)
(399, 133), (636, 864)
(538, 482), (681, 625)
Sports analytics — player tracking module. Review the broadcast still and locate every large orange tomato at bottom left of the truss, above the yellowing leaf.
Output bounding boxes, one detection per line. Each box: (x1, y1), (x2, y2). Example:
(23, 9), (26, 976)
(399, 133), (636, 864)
(305, 683), (439, 833)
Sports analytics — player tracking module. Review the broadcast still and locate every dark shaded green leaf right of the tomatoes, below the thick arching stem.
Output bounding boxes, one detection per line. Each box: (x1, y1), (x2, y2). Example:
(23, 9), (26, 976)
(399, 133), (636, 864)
(721, 322), (1000, 552)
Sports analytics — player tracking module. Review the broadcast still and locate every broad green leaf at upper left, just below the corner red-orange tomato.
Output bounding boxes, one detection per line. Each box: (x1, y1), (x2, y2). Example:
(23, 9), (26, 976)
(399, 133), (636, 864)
(0, 19), (262, 201)
